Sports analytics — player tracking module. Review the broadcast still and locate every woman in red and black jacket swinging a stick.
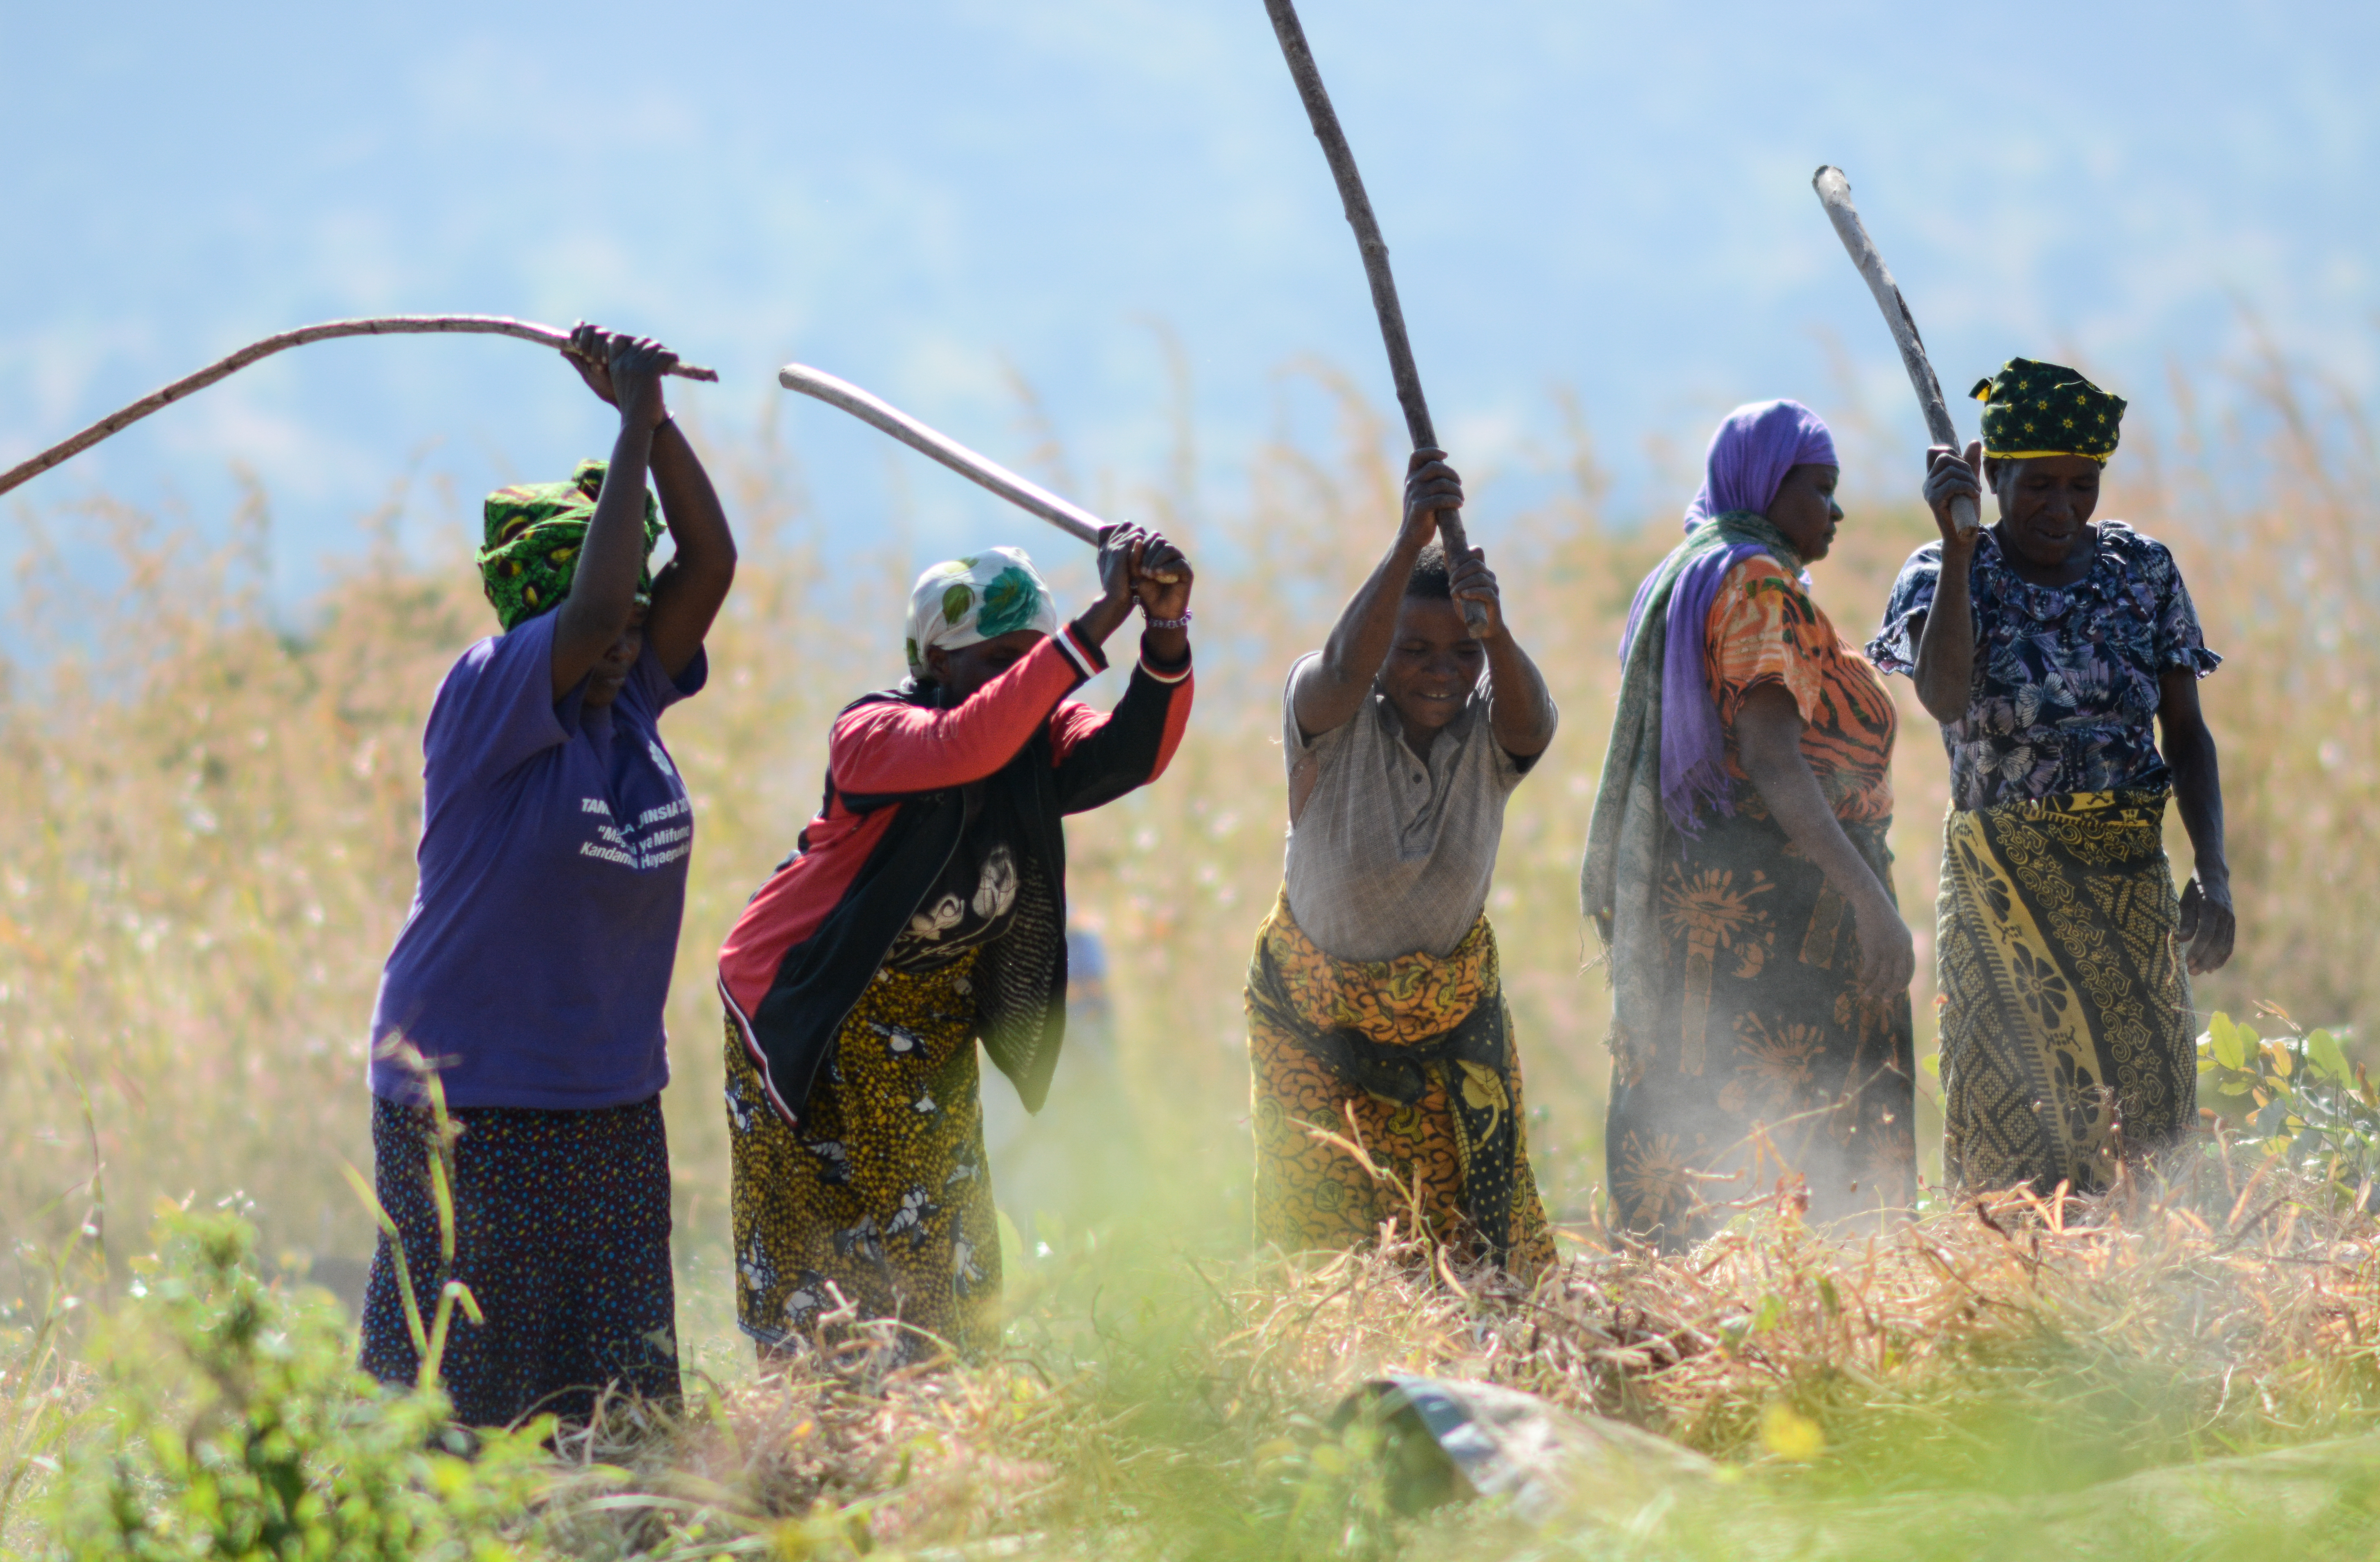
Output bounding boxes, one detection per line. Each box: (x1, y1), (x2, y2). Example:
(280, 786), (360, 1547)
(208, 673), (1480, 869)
(719, 526), (1190, 1357)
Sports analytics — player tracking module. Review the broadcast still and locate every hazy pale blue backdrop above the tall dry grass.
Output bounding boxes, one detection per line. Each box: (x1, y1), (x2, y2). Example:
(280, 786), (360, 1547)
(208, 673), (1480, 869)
(0, 0), (2380, 591)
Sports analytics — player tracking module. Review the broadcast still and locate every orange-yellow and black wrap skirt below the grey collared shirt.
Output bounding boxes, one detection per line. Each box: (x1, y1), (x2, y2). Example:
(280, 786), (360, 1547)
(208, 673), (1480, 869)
(1247, 895), (1554, 1279)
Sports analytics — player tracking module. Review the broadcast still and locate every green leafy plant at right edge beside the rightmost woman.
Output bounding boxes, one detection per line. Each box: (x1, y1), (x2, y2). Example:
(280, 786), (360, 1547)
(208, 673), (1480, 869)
(2199, 1005), (2380, 1207)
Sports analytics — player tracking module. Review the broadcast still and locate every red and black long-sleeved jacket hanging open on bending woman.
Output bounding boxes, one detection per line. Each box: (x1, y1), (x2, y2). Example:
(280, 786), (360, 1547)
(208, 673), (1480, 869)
(719, 624), (1192, 1124)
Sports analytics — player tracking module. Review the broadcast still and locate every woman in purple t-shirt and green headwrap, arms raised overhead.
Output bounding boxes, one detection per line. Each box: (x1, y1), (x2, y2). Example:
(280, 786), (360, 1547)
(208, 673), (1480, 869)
(364, 326), (736, 1426)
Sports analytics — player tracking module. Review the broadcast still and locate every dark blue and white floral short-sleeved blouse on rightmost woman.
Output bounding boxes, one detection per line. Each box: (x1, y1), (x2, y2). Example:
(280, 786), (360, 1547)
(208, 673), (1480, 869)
(1868, 522), (2223, 809)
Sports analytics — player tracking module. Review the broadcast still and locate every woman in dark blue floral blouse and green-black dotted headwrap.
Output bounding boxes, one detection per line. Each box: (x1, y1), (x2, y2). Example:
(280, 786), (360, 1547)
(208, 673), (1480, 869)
(1868, 357), (2235, 1193)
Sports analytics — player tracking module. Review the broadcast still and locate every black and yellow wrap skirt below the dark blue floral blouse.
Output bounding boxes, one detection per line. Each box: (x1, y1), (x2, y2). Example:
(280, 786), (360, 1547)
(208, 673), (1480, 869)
(1937, 793), (2199, 1193)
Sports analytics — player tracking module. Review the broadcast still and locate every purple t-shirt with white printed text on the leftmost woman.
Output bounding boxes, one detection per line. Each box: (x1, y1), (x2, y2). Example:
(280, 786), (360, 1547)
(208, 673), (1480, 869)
(371, 612), (707, 1109)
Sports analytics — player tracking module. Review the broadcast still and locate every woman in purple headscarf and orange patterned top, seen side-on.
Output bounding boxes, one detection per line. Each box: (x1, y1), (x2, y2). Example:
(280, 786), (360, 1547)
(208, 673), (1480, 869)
(1583, 400), (1916, 1248)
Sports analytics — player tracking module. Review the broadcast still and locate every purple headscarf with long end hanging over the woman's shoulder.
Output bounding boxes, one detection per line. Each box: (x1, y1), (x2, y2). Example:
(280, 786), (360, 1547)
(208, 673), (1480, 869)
(1628, 400), (1840, 836)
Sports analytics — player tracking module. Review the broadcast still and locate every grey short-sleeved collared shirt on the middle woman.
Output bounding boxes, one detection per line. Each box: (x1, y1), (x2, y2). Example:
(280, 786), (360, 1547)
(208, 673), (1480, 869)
(1281, 652), (1535, 959)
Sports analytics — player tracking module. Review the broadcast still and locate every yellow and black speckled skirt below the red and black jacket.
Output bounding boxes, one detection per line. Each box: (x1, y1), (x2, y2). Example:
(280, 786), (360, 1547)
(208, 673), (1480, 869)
(726, 955), (1000, 1360)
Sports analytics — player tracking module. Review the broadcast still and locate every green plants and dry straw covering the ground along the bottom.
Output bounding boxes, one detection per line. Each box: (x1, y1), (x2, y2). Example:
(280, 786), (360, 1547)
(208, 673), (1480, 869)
(14, 1145), (2380, 1562)
